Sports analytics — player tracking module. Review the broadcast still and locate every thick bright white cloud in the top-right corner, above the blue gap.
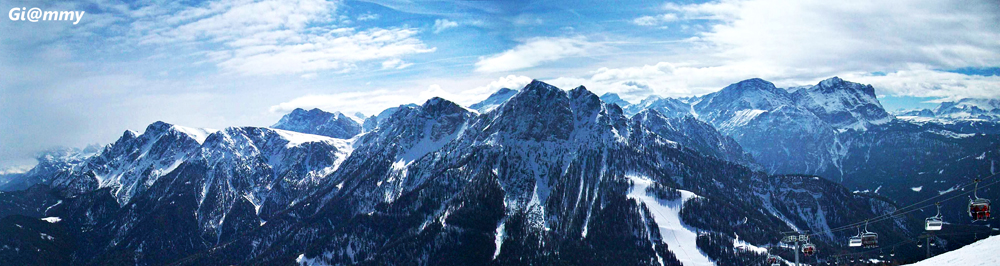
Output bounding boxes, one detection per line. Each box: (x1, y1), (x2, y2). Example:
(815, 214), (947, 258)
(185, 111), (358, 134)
(680, 0), (1000, 71)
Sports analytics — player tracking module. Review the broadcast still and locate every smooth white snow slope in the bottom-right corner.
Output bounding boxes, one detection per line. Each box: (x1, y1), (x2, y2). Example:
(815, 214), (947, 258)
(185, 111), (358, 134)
(908, 236), (1000, 266)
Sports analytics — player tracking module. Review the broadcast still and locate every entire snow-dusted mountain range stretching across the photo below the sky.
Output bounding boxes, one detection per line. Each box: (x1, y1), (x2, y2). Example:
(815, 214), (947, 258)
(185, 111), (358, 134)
(0, 78), (1000, 265)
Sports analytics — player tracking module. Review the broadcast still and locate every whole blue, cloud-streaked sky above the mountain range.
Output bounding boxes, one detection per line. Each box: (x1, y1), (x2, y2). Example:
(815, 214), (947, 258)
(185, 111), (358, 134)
(0, 0), (1000, 166)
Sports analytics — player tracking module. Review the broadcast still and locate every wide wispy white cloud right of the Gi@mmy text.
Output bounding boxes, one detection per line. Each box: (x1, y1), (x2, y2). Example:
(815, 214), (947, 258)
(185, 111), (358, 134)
(133, 0), (435, 75)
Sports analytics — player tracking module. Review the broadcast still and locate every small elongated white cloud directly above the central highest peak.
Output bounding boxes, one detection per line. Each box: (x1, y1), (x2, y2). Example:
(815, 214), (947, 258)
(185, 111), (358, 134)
(476, 37), (598, 73)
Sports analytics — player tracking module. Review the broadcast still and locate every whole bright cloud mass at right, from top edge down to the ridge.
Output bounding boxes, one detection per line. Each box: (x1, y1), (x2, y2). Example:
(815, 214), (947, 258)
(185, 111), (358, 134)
(551, 0), (1000, 100)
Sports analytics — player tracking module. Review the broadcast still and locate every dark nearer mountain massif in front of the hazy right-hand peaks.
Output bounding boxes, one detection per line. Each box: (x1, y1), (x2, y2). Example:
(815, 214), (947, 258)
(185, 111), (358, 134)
(0, 78), (952, 265)
